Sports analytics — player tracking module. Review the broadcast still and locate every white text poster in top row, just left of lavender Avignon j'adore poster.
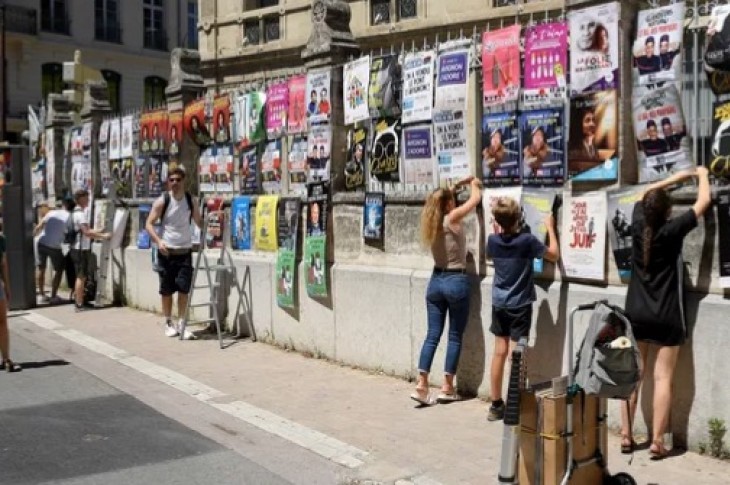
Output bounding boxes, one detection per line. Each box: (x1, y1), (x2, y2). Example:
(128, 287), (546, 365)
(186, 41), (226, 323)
(401, 51), (436, 125)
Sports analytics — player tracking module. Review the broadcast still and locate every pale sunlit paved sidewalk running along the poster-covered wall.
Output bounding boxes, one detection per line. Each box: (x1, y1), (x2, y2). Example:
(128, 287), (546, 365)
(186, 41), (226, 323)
(11, 305), (730, 485)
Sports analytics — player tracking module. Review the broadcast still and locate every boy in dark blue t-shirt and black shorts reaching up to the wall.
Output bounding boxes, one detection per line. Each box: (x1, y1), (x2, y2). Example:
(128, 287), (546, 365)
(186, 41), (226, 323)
(487, 197), (560, 421)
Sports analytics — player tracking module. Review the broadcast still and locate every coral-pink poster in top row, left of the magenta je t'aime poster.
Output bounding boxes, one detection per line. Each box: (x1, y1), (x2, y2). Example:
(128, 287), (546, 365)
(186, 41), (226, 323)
(482, 25), (521, 106)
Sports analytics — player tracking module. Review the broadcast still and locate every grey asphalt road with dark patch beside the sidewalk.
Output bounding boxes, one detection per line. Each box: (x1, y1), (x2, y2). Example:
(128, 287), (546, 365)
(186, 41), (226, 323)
(0, 333), (337, 485)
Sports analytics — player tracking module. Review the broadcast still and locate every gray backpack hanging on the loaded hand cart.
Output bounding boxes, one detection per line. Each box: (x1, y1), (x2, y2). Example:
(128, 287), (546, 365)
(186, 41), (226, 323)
(575, 302), (640, 399)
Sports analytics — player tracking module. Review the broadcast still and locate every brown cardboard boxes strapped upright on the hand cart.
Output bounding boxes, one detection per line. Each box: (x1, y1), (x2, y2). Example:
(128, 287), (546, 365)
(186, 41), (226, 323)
(519, 389), (607, 485)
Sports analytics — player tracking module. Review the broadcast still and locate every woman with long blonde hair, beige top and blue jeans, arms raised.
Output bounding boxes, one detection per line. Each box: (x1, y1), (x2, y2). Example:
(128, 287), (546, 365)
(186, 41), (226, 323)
(411, 177), (482, 405)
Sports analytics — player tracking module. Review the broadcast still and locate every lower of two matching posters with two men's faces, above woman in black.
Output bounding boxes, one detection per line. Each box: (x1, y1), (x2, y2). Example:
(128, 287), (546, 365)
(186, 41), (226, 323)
(633, 84), (694, 182)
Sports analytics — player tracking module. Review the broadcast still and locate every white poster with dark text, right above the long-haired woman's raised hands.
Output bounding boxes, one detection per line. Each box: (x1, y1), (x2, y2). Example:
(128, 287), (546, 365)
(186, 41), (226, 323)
(433, 111), (470, 180)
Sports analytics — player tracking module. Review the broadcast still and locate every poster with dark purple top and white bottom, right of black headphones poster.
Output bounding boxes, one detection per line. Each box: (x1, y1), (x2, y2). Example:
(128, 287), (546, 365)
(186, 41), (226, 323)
(403, 125), (436, 185)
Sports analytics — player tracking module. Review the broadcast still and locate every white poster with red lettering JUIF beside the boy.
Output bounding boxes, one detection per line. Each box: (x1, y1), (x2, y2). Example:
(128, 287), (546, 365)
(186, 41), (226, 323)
(560, 192), (606, 281)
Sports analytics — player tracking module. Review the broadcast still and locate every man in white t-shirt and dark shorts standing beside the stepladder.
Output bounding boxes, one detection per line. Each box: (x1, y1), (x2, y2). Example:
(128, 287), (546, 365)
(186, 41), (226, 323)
(145, 166), (202, 340)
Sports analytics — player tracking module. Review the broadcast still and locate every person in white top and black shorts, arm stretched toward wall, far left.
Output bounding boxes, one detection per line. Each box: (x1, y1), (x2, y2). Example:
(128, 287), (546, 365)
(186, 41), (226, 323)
(65, 189), (111, 312)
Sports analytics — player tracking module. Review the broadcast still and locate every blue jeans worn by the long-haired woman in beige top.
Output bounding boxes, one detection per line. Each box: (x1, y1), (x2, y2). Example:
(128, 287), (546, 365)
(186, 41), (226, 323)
(418, 272), (470, 374)
